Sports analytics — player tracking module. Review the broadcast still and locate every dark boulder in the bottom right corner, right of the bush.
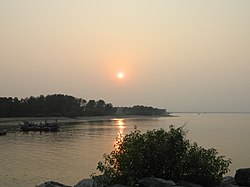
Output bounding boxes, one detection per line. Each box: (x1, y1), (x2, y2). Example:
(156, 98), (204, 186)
(234, 168), (250, 186)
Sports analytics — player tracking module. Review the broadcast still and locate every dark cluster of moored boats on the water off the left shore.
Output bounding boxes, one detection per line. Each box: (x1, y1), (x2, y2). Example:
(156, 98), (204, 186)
(19, 121), (59, 132)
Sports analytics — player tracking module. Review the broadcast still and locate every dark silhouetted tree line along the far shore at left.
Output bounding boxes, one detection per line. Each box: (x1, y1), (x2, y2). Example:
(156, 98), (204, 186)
(0, 94), (167, 117)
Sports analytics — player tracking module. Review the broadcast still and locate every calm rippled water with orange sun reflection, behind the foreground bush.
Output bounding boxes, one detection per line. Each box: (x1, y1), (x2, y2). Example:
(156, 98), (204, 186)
(0, 114), (250, 187)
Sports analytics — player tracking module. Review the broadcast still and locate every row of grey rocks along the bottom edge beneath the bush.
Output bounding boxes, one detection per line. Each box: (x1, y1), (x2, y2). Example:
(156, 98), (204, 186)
(36, 168), (250, 187)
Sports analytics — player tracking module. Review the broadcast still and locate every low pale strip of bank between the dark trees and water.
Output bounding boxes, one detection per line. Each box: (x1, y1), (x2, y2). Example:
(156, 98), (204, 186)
(0, 114), (174, 128)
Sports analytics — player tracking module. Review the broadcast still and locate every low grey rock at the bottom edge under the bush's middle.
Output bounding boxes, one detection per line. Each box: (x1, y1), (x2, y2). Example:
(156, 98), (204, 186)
(138, 177), (176, 187)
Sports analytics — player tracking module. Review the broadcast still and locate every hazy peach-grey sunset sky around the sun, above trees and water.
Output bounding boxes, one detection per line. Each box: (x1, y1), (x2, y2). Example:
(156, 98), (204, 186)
(0, 0), (250, 112)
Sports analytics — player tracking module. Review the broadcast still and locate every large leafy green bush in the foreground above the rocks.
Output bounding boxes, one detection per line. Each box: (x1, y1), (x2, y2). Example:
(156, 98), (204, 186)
(97, 126), (231, 186)
